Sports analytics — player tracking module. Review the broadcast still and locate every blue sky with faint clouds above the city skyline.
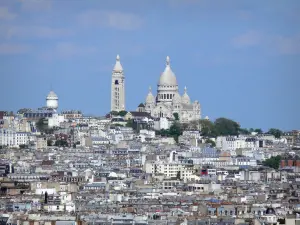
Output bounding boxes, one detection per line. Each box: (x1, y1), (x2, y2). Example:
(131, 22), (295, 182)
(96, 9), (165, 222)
(0, 0), (300, 130)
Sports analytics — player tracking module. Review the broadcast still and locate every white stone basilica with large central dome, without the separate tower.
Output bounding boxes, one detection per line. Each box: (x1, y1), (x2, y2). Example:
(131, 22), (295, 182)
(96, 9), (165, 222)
(145, 57), (201, 122)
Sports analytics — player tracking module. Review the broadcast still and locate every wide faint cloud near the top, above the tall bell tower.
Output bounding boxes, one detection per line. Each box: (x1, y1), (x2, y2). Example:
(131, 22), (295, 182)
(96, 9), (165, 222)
(78, 10), (142, 30)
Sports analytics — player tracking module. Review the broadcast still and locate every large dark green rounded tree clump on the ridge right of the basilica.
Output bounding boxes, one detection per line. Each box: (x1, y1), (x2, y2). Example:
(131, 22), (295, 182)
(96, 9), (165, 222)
(214, 118), (240, 136)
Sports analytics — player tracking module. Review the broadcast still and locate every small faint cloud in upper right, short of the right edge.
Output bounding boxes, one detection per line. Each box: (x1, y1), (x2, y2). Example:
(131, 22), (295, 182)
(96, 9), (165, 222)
(232, 30), (262, 47)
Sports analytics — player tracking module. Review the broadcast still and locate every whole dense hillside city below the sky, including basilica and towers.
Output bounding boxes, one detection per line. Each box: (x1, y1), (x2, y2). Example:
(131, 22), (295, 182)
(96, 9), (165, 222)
(0, 55), (300, 225)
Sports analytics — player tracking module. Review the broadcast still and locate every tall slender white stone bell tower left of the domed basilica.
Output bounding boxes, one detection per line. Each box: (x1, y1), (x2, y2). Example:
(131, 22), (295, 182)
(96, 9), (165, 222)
(111, 55), (125, 112)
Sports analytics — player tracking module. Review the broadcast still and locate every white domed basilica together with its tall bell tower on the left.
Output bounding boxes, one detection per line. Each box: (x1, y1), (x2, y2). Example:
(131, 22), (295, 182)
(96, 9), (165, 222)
(111, 55), (201, 123)
